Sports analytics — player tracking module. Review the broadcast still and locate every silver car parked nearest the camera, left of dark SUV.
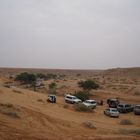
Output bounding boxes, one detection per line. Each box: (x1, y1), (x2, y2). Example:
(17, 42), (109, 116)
(104, 108), (119, 118)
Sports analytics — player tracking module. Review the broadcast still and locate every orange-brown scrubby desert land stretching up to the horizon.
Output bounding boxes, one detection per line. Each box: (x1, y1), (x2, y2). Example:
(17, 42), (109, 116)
(0, 68), (140, 140)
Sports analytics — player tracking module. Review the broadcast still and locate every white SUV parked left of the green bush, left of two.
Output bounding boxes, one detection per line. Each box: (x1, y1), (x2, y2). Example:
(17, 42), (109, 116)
(65, 94), (82, 104)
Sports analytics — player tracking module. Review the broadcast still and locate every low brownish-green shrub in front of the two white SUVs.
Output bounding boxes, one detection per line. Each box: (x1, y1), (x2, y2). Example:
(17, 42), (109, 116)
(74, 103), (93, 112)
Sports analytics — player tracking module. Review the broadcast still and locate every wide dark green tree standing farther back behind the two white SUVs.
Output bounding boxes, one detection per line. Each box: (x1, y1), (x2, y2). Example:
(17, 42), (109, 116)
(78, 80), (99, 91)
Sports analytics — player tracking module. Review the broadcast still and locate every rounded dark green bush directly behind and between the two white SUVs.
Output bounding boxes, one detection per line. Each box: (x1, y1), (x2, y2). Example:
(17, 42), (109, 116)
(74, 91), (89, 101)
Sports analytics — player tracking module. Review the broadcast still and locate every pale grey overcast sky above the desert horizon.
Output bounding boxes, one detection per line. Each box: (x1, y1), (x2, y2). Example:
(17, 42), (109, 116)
(0, 0), (140, 69)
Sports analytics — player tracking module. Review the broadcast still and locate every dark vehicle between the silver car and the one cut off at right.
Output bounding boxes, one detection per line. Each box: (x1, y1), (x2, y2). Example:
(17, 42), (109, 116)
(117, 104), (134, 113)
